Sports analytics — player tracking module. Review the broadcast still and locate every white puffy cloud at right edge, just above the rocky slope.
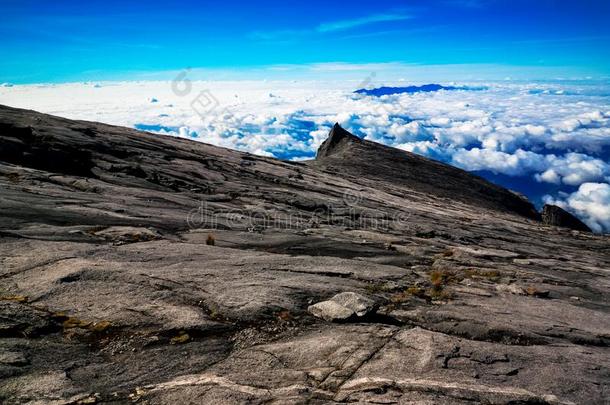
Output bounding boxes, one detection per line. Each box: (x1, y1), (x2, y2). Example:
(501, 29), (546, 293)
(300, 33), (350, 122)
(545, 183), (610, 232)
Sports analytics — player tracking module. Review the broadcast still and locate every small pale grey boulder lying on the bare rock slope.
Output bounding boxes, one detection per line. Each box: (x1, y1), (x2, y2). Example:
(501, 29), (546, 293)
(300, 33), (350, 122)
(307, 292), (377, 322)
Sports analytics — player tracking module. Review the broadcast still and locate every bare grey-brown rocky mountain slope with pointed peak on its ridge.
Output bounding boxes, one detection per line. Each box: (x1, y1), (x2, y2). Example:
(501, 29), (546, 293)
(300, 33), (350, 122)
(0, 107), (610, 404)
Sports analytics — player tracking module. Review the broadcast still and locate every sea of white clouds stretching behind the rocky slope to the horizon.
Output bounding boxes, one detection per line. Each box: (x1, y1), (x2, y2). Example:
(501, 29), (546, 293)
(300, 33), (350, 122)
(0, 79), (610, 232)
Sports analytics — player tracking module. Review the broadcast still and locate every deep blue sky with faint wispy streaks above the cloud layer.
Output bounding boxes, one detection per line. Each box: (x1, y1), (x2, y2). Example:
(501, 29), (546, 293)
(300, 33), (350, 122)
(0, 0), (610, 83)
